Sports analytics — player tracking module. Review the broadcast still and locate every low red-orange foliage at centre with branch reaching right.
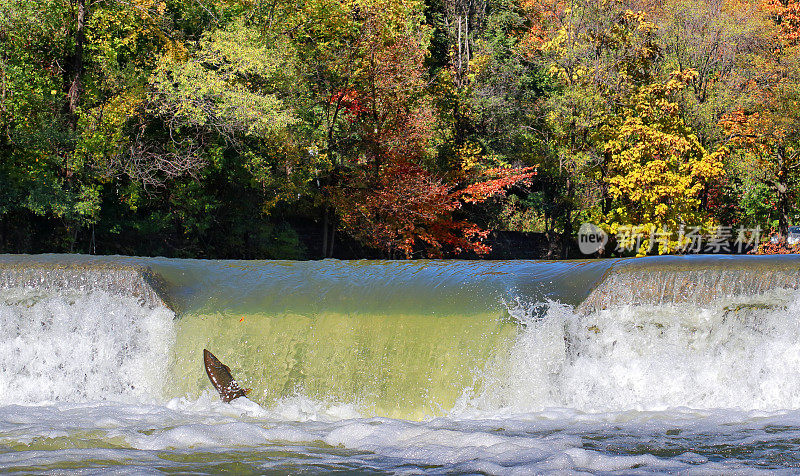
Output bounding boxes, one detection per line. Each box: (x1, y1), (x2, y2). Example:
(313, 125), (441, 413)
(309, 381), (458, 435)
(330, 161), (536, 258)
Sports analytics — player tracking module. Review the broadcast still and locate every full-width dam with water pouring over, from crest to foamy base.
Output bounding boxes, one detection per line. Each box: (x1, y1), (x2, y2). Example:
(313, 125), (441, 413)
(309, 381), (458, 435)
(0, 255), (800, 419)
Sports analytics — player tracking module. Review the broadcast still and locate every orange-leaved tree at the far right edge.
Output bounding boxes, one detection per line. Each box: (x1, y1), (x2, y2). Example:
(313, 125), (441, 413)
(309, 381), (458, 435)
(719, 0), (800, 235)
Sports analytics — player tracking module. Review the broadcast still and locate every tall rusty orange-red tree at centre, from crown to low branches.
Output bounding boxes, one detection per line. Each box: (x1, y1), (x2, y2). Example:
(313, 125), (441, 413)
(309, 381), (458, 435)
(327, 0), (536, 258)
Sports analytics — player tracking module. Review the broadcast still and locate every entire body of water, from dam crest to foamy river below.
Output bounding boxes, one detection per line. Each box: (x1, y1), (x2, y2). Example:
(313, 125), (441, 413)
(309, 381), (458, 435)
(0, 256), (800, 474)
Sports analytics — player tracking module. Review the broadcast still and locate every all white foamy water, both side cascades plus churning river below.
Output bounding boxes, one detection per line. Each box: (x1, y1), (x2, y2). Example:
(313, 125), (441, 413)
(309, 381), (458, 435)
(0, 282), (800, 474)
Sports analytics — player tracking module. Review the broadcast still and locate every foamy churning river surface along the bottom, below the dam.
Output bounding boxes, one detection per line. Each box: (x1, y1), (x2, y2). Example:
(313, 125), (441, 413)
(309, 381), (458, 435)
(0, 400), (800, 474)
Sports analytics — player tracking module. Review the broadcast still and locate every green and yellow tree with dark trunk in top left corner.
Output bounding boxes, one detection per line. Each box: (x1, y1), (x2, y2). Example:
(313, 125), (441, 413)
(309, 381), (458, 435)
(0, 0), (189, 249)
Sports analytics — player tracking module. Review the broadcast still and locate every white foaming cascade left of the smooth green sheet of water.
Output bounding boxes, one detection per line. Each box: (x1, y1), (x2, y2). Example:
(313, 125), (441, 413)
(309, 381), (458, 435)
(0, 288), (174, 404)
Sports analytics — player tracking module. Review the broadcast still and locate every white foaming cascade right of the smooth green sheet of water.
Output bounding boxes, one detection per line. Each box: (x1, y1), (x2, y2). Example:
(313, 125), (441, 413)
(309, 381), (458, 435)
(459, 290), (800, 412)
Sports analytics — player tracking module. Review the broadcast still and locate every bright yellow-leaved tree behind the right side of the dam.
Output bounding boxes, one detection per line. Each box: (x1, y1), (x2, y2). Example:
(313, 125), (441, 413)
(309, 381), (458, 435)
(603, 70), (724, 254)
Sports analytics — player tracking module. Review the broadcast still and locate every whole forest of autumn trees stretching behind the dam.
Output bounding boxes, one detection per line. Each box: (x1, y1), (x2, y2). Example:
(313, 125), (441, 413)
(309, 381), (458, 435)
(0, 0), (800, 259)
